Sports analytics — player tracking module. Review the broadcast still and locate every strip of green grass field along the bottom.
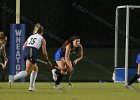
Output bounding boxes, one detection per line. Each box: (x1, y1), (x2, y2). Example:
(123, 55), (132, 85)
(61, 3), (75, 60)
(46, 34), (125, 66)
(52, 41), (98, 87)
(0, 82), (140, 100)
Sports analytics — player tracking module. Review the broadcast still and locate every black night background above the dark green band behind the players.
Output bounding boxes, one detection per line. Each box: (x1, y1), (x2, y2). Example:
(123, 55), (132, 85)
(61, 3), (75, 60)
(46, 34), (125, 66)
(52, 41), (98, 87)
(0, 0), (140, 47)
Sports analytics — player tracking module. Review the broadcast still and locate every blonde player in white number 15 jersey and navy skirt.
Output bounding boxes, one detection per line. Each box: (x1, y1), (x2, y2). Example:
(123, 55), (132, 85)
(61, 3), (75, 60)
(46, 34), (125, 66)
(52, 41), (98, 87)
(9, 23), (52, 91)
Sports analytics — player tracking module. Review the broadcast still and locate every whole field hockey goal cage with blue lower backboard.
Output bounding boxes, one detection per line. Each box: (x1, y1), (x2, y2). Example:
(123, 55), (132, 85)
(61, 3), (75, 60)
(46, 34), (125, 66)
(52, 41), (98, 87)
(112, 5), (140, 84)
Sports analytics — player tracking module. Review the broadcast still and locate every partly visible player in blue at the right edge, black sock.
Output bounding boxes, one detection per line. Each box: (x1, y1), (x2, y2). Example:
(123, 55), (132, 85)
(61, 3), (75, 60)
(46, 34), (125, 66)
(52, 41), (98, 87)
(125, 53), (140, 89)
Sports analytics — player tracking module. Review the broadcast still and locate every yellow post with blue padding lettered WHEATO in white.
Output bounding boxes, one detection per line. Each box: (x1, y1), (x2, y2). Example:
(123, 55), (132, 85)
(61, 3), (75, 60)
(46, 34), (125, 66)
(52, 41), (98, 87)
(9, 0), (26, 82)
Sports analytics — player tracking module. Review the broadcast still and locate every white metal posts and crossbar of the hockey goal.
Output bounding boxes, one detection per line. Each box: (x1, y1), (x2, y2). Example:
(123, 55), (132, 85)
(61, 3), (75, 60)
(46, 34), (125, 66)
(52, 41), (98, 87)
(113, 5), (140, 84)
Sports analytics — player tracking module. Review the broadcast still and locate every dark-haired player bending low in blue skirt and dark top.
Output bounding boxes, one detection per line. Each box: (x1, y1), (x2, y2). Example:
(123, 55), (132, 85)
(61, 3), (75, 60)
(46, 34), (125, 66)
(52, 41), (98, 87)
(52, 36), (83, 88)
